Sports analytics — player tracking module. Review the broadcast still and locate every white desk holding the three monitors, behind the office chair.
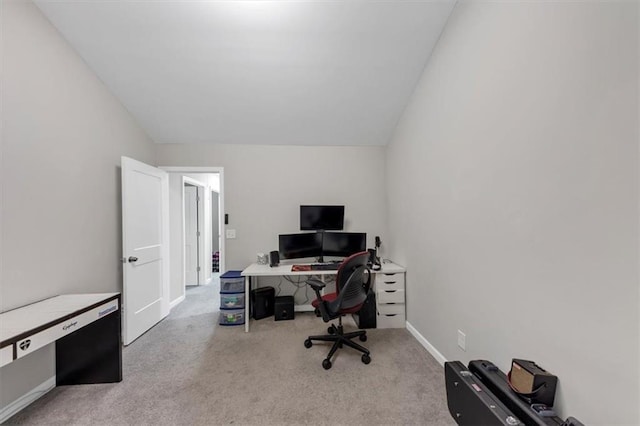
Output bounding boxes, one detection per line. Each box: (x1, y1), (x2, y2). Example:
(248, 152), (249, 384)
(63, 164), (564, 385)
(241, 262), (405, 332)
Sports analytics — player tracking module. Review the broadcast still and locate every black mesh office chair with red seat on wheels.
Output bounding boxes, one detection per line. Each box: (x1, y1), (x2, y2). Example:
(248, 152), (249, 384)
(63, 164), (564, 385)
(304, 251), (371, 370)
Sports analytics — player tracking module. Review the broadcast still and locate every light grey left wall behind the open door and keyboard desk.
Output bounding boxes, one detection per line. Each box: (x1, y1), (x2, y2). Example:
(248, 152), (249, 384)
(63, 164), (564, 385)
(0, 0), (155, 409)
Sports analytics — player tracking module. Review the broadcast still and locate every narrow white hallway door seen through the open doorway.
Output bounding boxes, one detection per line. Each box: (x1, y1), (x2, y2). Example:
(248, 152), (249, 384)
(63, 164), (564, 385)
(184, 184), (199, 285)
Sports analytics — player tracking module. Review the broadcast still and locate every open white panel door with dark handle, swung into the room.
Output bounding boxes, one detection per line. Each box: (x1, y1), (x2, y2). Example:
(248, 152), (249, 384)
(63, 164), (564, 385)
(121, 157), (169, 345)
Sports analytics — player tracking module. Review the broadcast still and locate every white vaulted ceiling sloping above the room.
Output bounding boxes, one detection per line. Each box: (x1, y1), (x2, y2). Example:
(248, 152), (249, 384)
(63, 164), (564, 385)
(36, 0), (455, 145)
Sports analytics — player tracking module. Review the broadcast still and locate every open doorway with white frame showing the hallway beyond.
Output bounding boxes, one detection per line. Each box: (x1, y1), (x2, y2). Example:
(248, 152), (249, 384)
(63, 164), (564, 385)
(161, 167), (224, 307)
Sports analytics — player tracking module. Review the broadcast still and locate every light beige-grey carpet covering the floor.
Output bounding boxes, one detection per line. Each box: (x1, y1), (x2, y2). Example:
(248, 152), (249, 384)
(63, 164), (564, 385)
(7, 285), (455, 425)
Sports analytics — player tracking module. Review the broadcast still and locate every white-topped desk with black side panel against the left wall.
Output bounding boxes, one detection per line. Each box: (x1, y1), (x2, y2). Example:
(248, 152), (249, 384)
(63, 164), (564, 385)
(0, 293), (122, 385)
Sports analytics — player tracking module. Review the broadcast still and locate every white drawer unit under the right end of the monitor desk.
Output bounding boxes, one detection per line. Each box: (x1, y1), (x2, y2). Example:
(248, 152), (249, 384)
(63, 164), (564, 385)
(374, 265), (406, 328)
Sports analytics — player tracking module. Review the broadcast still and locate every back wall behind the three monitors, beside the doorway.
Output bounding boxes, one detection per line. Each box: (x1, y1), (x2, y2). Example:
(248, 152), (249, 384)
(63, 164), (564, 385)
(157, 144), (386, 272)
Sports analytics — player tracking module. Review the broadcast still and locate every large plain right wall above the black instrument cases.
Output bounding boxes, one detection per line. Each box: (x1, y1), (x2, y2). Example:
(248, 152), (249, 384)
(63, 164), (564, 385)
(387, 1), (640, 425)
